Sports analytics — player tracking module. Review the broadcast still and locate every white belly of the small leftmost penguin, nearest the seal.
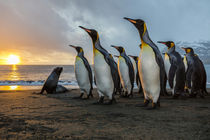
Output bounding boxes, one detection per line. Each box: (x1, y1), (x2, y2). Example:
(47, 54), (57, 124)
(74, 56), (90, 92)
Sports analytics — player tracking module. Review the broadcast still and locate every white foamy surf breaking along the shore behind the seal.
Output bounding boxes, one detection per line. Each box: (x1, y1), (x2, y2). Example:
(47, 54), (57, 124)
(0, 80), (77, 86)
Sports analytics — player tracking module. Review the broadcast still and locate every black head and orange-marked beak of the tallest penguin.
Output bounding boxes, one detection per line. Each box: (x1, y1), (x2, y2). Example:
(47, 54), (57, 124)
(124, 17), (147, 37)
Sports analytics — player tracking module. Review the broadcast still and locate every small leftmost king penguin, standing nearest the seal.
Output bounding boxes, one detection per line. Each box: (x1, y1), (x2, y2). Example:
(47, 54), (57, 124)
(69, 45), (93, 99)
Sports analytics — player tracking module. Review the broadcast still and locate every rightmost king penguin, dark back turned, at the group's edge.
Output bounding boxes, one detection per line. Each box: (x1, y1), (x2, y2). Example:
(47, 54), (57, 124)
(182, 47), (207, 97)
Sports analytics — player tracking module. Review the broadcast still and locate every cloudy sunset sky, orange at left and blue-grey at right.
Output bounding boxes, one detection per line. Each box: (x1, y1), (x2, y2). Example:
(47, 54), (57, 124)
(0, 0), (210, 65)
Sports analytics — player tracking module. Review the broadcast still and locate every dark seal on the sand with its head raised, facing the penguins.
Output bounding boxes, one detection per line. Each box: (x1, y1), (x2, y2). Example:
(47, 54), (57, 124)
(40, 67), (68, 94)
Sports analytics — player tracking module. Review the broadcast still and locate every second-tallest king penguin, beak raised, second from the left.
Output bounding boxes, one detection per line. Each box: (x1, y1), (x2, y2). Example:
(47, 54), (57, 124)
(79, 26), (118, 104)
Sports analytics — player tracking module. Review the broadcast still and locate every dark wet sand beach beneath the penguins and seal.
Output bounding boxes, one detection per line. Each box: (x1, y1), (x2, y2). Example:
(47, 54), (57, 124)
(0, 89), (210, 140)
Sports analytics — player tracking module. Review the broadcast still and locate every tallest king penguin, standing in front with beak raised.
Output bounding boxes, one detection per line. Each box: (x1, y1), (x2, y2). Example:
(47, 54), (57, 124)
(124, 18), (166, 109)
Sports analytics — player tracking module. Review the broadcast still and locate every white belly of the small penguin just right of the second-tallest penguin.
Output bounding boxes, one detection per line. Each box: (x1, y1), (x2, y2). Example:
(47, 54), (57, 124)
(118, 56), (131, 92)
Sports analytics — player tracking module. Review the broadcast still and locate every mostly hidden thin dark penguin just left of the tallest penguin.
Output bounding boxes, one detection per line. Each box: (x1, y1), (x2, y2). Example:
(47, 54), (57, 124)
(128, 55), (142, 93)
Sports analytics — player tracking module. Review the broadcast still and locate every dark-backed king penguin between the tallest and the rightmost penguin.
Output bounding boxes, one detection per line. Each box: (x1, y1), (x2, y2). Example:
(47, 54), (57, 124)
(158, 41), (185, 98)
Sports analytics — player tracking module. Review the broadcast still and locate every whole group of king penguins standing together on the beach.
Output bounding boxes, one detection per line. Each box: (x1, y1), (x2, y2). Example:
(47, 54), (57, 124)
(69, 17), (207, 109)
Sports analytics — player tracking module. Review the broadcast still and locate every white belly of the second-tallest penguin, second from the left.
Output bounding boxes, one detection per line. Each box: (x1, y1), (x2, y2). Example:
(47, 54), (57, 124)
(94, 50), (114, 96)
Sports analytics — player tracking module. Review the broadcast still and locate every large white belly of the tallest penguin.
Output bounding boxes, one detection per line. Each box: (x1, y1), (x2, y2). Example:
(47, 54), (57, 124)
(138, 46), (160, 102)
